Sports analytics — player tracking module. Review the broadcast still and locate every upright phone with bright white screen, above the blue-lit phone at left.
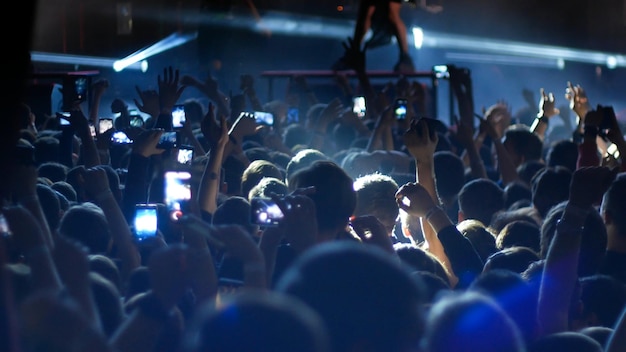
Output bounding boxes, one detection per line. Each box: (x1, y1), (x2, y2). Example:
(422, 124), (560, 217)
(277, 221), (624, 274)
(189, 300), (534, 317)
(164, 171), (191, 221)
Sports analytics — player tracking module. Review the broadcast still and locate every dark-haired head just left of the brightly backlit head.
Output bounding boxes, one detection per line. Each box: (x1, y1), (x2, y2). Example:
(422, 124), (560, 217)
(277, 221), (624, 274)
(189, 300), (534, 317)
(287, 160), (357, 231)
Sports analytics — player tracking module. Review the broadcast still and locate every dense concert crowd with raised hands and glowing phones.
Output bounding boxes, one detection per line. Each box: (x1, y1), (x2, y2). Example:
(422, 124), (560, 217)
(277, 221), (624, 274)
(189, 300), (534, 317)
(0, 30), (626, 352)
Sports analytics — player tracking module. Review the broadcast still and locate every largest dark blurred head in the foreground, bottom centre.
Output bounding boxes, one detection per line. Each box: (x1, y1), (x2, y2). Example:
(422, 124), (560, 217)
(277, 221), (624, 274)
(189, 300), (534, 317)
(276, 241), (424, 352)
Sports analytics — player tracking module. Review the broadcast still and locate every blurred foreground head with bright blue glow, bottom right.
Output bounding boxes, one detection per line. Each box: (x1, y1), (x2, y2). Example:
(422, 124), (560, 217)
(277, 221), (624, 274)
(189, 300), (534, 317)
(423, 291), (525, 352)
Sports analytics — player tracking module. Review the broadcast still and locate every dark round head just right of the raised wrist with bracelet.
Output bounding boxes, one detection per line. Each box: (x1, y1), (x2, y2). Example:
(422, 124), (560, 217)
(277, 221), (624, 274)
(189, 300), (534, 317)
(459, 178), (504, 226)
